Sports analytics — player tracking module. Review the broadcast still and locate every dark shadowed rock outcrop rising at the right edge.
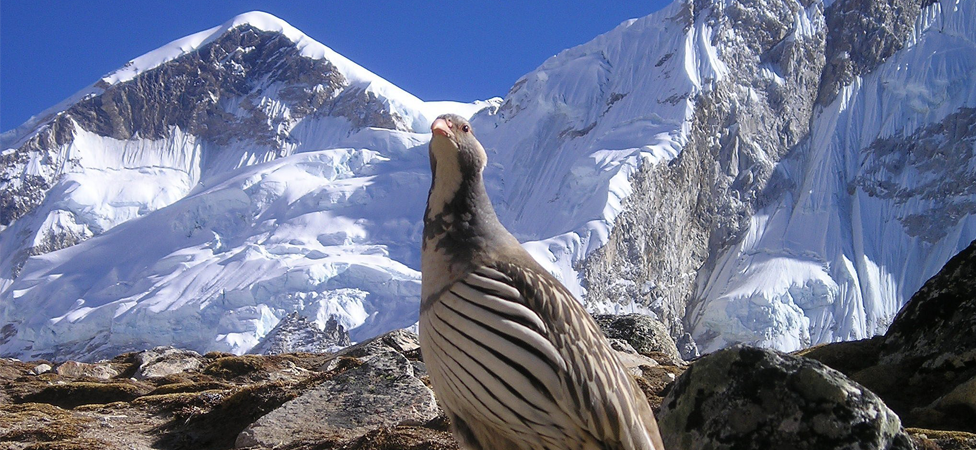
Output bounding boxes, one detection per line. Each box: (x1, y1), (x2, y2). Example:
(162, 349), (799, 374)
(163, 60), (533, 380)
(800, 242), (976, 432)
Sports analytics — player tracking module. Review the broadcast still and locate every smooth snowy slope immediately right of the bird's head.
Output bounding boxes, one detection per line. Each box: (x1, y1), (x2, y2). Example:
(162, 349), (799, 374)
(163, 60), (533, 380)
(473, 2), (724, 298)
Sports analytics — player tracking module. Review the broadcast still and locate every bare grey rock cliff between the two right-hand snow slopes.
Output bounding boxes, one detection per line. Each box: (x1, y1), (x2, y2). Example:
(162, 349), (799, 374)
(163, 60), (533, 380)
(584, 1), (826, 346)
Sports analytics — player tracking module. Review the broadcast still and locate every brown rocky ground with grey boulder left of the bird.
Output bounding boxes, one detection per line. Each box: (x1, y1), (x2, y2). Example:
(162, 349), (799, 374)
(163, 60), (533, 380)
(0, 331), (457, 450)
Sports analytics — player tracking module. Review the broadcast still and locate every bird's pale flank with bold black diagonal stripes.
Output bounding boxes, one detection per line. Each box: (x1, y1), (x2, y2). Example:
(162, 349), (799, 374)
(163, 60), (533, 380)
(421, 268), (573, 439)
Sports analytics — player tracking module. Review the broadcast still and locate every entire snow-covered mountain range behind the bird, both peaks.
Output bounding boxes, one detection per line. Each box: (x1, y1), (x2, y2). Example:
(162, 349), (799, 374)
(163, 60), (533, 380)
(0, 0), (976, 359)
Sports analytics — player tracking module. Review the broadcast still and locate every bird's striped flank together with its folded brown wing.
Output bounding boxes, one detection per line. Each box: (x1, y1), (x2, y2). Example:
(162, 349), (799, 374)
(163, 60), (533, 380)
(426, 263), (653, 449)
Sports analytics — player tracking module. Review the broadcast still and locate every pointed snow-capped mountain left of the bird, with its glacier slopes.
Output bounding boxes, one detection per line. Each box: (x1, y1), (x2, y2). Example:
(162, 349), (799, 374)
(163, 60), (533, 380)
(0, 13), (497, 359)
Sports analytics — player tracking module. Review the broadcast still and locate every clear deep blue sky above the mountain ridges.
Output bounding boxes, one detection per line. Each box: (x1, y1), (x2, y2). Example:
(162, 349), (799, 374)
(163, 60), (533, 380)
(0, 0), (669, 132)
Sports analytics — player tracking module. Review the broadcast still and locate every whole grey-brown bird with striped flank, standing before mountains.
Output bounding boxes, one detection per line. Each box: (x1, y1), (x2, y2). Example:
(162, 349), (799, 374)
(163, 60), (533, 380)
(419, 114), (664, 450)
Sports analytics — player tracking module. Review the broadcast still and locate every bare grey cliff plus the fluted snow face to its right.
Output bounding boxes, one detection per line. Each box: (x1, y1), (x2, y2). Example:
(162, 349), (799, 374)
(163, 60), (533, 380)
(583, 1), (976, 351)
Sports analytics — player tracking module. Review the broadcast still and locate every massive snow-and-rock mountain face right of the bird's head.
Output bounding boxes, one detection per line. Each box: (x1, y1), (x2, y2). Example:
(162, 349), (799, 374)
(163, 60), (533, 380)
(473, 0), (976, 351)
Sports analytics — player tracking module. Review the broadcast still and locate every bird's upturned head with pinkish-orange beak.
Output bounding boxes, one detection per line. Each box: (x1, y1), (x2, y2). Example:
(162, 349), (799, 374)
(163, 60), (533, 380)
(430, 114), (488, 177)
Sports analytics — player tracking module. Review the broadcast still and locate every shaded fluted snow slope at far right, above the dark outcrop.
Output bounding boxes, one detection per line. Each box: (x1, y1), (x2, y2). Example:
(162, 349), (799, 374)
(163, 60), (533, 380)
(689, 1), (976, 350)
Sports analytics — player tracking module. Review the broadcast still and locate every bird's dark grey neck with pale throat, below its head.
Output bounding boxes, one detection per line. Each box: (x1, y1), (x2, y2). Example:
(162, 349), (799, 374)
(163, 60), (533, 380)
(421, 163), (508, 299)
